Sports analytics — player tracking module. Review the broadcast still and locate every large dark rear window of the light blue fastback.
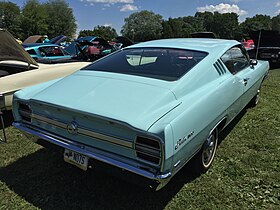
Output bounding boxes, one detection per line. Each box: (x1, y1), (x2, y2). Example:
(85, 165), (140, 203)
(83, 48), (207, 81)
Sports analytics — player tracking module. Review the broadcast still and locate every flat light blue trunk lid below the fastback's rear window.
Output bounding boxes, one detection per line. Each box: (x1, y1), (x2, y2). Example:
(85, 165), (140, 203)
(32, 70), (179, 130)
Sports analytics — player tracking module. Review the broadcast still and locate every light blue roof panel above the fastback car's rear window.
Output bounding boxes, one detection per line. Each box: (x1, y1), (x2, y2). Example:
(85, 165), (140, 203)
(127, 38), (240, 53)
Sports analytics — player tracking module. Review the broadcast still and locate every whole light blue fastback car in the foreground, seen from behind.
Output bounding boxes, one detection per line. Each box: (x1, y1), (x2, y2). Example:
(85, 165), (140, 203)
(13, 39), (269, 189)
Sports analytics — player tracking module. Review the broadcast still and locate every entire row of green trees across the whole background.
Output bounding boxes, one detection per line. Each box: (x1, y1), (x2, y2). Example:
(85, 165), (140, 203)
(0, 0), (280, 42)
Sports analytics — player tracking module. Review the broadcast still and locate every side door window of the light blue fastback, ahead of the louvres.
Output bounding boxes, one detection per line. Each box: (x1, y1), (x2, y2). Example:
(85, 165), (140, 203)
(221, 47), (250, 74)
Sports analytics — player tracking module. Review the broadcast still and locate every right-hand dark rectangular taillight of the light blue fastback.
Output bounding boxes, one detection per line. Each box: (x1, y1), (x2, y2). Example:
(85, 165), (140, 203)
(135, 137), (161, 165)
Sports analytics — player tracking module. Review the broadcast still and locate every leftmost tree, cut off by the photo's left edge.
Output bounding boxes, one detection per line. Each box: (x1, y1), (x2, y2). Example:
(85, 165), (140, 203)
(0, 1), (20, 37)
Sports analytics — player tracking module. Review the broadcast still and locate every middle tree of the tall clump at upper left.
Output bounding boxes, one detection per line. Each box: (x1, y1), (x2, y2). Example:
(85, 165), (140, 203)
(21, 0), (48, 38)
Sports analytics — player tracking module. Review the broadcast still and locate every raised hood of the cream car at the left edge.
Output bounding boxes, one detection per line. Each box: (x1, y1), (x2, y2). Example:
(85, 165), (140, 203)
(0, 29), (38, 67)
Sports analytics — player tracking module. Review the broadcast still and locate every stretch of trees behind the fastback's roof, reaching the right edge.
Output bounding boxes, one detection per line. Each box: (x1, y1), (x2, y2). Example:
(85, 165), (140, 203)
(121, 11), (280, 42)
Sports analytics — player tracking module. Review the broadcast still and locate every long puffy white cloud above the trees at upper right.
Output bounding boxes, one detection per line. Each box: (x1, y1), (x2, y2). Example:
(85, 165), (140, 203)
(196, 3), (247, 16)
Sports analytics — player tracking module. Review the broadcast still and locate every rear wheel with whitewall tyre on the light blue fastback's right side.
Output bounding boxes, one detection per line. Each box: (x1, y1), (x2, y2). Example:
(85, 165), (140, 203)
(193, 128), (218, 174)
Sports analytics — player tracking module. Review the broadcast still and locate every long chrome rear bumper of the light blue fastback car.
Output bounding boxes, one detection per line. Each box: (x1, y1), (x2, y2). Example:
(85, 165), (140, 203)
(13, 122), (172, 190)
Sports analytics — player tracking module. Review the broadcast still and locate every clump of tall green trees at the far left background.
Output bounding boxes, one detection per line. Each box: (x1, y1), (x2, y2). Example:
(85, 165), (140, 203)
(0, 0), (77, 40)
